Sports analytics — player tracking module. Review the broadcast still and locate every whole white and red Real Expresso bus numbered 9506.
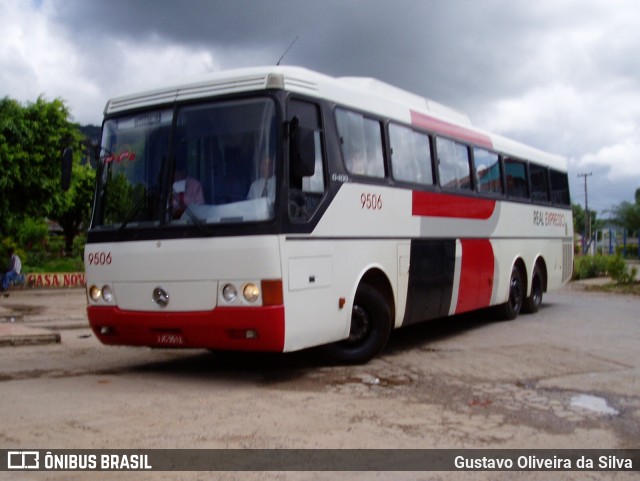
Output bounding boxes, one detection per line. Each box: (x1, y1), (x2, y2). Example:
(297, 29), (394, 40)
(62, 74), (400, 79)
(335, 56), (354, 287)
(85, 67), (573, 362)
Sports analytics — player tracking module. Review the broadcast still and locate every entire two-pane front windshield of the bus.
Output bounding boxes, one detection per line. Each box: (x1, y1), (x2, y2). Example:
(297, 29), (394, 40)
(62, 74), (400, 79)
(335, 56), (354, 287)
(92, 98), (277, 230)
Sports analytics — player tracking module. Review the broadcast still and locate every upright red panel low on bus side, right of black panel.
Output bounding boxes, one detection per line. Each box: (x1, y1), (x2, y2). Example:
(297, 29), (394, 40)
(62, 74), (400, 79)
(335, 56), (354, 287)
(456, 239), (494, 314)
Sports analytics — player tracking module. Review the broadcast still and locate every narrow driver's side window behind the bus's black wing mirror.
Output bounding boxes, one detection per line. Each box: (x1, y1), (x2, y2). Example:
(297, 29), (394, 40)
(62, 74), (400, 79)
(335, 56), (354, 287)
(289, 99), (326, 220)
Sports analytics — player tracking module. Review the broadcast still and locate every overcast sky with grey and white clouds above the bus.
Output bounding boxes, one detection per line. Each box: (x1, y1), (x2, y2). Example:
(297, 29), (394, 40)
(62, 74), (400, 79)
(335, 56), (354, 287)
(0, 0), (640, 215)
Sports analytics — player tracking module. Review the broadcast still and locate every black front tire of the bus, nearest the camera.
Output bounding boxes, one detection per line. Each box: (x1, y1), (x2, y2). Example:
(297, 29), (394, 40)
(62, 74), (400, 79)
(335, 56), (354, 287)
(324, 284), (391, 364)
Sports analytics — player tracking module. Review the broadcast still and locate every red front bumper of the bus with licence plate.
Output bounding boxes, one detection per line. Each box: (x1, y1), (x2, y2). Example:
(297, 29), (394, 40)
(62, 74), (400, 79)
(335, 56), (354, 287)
(87, 305), (285, 352)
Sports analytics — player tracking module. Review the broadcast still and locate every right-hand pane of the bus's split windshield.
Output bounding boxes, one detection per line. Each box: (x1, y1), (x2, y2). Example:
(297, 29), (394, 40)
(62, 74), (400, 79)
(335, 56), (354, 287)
(170, 98), (276, 224)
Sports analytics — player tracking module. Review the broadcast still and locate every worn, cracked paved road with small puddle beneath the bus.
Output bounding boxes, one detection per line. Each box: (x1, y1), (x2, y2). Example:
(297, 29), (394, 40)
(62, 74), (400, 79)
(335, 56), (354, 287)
(0, 286), (640, 480)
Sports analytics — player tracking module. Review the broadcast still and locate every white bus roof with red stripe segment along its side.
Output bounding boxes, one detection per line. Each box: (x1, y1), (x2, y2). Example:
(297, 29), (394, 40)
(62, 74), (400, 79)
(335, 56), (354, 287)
(104, 66), (566, 170)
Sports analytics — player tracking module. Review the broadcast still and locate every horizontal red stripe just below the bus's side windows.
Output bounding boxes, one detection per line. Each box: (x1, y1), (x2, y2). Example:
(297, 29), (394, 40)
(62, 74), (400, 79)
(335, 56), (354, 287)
(411, 191), (496, 220)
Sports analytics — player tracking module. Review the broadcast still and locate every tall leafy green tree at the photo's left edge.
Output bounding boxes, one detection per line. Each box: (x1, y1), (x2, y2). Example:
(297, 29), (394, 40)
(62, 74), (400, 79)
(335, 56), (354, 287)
(0, 97), (84, 244)
